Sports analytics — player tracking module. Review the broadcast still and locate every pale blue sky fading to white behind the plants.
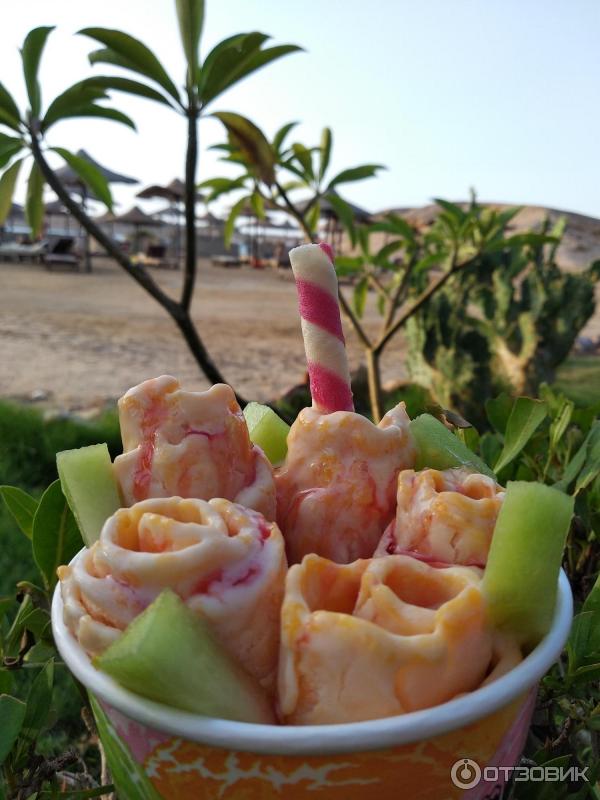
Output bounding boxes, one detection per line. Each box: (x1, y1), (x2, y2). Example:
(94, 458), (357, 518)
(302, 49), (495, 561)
(0, 0), (600, 217)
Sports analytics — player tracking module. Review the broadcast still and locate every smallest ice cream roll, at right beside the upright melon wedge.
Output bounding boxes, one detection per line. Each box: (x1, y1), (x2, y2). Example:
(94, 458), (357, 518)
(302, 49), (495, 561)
(376, 468), (504, 567)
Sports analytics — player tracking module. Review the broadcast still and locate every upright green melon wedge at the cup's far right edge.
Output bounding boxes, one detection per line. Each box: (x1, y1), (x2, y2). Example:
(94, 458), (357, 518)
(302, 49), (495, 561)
(481, 481), (574, 649)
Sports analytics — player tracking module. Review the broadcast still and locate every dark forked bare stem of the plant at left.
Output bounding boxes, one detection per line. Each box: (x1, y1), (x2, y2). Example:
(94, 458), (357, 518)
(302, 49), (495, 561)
(30, 134), (237, 394)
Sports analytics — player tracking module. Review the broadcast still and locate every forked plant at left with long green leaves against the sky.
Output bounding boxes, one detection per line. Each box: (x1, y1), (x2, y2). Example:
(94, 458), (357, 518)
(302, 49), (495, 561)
(0, 0), (300, 400)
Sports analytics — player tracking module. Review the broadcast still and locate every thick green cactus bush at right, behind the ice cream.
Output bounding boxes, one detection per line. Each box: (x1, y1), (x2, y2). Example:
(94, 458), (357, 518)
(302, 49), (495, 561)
(406, 201), (600, 420)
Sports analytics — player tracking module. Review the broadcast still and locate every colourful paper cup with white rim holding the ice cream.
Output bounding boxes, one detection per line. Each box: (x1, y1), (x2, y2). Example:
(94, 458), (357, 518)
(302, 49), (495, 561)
(52, 573), (573, 800)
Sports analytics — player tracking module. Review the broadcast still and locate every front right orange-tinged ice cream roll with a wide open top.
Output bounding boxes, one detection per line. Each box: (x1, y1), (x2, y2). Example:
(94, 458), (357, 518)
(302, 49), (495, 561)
(278, 555), (520, 725)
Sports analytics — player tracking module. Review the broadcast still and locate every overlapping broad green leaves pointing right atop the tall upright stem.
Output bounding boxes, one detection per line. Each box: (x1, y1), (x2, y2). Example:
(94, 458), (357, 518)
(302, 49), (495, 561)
(198, 31), (301, 106)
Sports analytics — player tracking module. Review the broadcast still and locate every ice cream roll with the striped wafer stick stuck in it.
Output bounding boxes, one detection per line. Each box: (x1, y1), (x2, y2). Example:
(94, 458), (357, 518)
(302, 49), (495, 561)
(276, 403), (415, 563)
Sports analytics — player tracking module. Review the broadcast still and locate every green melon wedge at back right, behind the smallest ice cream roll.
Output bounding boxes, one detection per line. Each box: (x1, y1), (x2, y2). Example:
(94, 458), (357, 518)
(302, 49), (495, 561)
(410, 414), (496, 478)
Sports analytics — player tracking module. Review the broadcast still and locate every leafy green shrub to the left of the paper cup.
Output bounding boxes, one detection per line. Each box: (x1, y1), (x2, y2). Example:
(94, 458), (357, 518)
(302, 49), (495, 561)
(0, 481), (112, 800)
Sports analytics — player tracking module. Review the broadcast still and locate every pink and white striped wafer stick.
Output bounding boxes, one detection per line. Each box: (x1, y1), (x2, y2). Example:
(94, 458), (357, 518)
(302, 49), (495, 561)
(290, 244), (354, 414)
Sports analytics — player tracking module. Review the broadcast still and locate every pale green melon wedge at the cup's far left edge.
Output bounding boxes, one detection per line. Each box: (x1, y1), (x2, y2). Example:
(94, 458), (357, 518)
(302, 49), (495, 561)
(56, 444), (122, 547)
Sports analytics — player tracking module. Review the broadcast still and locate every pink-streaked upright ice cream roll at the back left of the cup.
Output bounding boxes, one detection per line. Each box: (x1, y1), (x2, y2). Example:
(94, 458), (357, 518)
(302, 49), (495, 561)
(114, 375), (275, 520)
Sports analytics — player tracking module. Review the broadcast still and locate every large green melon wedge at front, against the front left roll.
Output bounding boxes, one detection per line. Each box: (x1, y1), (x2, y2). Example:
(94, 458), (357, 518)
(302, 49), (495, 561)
(94, 589), (275, 724)
